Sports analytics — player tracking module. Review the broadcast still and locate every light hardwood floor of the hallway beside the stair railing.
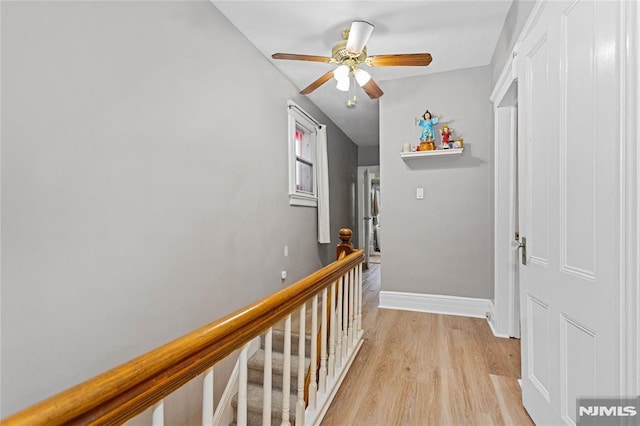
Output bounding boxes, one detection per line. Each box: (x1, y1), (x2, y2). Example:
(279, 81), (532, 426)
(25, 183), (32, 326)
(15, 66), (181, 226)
(322, 264), (533, 426)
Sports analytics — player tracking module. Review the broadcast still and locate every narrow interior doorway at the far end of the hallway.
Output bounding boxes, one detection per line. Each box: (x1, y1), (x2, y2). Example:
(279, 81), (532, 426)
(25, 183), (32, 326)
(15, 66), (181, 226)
(357, 166), (382, 268)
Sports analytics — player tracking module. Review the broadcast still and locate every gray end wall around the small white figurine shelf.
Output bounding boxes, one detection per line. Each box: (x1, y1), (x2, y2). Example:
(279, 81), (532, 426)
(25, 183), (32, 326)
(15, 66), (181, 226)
(380, 67), (493, 298)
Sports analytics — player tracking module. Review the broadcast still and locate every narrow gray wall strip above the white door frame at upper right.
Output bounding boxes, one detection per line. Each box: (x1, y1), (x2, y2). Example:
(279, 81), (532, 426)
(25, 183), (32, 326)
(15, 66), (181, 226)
(490, 0), (536, 89)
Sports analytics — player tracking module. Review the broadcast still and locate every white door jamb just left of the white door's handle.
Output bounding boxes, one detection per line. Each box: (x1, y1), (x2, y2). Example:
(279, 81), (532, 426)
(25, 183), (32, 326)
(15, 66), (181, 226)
(489, 54), (520, 337)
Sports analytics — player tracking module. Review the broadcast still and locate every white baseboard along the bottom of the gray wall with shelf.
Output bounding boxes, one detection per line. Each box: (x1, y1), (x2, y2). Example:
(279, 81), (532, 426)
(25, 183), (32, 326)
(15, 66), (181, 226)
(378, 291), (492, 318)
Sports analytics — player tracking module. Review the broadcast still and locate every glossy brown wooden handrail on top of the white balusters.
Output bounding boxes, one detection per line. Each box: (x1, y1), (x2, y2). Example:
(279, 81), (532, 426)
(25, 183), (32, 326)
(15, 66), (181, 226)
(0, 237), (364, 426)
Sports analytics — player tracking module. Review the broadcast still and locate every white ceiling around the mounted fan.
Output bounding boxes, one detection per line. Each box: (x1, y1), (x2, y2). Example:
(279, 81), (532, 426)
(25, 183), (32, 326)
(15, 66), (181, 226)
(212, 0), (512, 146)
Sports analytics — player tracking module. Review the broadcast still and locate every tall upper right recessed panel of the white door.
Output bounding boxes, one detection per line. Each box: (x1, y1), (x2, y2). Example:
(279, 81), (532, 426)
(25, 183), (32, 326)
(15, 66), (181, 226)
(559, 1), (598, 279)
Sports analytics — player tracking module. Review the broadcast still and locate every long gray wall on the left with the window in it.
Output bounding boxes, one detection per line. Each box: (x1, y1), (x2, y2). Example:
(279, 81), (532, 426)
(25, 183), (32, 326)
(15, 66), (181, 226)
(1, 1), (357, 416)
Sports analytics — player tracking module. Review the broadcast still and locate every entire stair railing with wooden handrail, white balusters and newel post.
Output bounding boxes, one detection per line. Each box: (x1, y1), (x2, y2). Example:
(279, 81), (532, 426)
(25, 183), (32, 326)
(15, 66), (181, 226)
(0, 229), (364, 426)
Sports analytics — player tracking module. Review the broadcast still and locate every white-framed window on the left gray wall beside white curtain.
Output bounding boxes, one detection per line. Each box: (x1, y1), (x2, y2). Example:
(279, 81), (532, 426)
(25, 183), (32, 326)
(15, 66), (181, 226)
(288, 101), (320, 207)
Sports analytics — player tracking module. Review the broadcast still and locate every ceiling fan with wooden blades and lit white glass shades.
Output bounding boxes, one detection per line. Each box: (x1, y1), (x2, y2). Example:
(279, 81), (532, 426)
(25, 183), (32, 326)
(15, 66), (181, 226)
(271, 21), (432, 108)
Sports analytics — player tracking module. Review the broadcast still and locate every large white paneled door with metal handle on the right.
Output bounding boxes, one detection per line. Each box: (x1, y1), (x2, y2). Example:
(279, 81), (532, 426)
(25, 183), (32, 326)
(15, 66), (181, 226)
(517, 0), (624, 425)
